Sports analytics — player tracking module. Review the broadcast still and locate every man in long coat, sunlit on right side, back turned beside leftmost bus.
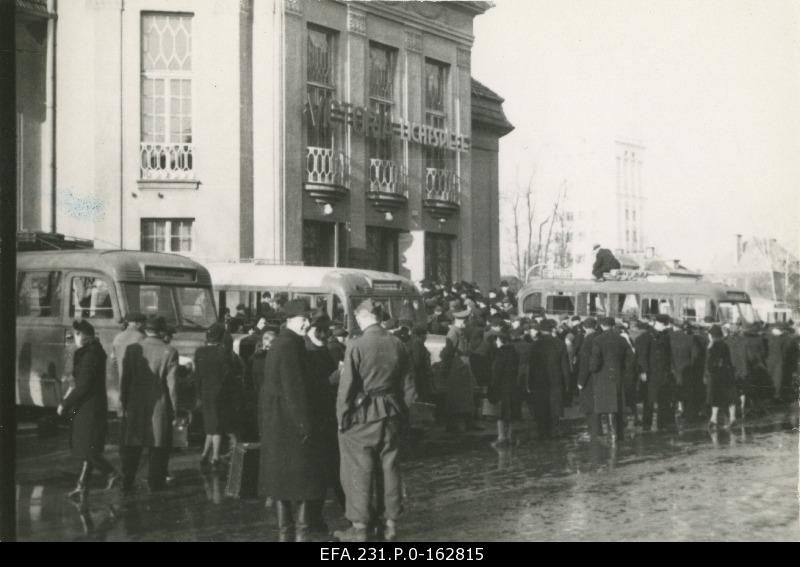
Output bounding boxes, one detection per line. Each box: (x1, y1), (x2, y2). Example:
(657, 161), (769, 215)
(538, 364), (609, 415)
(120, 316), (178, 491)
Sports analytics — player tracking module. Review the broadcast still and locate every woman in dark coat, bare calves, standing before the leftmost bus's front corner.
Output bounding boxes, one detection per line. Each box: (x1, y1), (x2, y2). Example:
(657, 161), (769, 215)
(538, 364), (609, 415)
(194, 323), (240, 467)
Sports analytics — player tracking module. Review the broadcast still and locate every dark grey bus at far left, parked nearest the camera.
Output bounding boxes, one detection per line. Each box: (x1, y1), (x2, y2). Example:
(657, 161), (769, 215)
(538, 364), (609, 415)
(16, 249), (216, 411)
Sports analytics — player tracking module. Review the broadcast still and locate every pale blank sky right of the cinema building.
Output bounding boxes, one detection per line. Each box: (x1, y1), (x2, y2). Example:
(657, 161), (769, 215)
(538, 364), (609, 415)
(472, 0), (800, 273)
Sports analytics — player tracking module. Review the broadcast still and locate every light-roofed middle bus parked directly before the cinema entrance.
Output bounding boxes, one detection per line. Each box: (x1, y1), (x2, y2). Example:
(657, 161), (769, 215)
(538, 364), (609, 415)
(206, 262), (443, 358)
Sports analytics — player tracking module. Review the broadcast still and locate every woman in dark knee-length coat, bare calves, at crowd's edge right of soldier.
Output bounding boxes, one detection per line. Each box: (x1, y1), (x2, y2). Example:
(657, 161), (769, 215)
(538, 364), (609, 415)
(487, 330), (522, 447)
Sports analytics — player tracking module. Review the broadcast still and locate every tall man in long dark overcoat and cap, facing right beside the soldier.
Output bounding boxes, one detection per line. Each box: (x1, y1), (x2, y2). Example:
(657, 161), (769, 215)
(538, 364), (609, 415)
(258, 299), (328, 541)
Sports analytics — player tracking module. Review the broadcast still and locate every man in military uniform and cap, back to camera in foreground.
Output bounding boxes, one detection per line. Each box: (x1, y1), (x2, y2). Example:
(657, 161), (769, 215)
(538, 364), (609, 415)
(334, 299), (416, 541)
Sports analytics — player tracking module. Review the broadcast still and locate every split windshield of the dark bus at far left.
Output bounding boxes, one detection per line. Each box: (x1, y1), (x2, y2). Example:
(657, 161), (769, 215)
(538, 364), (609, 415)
(122, 284), (216, 330)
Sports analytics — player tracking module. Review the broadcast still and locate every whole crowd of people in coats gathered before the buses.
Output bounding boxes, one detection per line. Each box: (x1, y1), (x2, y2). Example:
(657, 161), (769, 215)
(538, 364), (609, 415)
(58, 281), (798, 541)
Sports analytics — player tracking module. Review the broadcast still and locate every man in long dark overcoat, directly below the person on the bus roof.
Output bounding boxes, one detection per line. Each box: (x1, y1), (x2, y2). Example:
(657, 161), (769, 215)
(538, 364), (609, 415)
(590, 317), (635, 442)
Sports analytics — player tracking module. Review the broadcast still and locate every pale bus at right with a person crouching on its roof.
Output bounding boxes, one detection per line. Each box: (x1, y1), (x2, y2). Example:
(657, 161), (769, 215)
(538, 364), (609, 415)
(517, 271), (757, 323)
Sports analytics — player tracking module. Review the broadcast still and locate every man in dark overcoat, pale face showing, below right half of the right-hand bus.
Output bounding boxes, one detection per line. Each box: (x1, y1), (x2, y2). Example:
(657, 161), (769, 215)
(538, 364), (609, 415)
(637, 315), (675, 431)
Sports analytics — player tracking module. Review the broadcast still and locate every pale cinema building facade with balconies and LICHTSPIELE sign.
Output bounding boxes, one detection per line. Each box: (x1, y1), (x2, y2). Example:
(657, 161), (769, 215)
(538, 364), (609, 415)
(22, 0), (513, 286)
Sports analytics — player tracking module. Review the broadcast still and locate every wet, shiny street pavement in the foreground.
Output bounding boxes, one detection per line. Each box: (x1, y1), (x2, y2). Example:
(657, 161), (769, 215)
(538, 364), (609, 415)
(12, 406), (800, 541)
